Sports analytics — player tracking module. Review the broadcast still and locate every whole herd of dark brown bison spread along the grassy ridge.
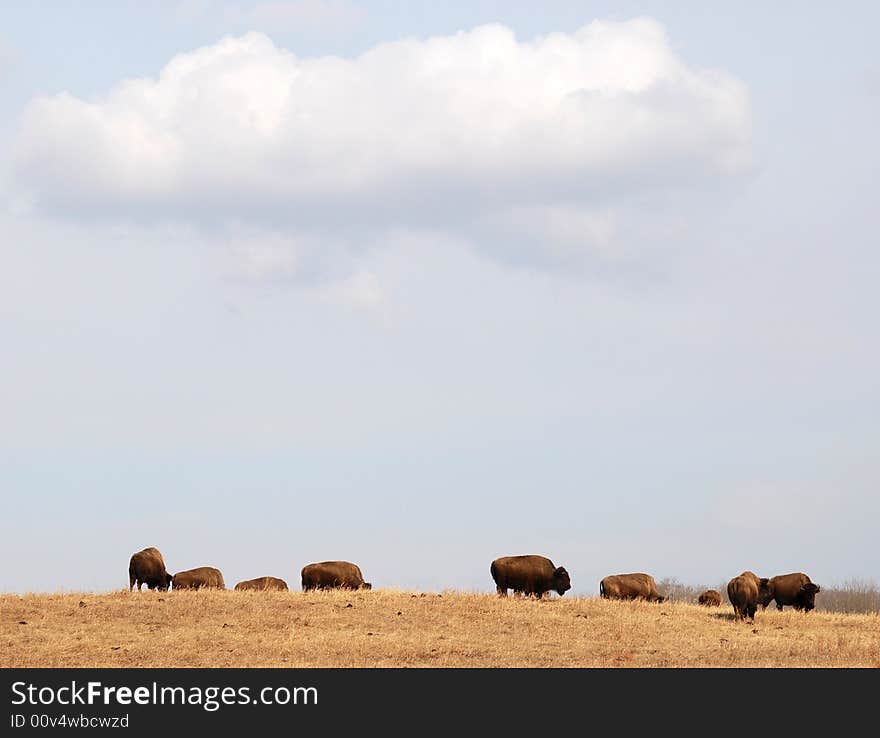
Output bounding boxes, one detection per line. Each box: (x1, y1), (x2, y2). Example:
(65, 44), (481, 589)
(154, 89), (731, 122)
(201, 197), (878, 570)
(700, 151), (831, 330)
(128, 547), (819, 620)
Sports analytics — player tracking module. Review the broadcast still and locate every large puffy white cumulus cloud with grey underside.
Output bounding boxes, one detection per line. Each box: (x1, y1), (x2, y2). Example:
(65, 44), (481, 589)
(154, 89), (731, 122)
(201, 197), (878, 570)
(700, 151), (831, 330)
(15, 18), (751, 275)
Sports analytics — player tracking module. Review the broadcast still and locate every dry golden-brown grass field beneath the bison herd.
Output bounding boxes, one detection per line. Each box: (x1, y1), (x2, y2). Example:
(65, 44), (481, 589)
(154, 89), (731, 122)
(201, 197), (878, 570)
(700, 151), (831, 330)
(0, 590), (880, 667)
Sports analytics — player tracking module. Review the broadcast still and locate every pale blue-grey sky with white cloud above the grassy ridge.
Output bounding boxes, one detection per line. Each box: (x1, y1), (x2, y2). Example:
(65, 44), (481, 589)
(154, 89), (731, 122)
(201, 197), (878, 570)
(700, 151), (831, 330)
(0, 0), (880, 595)
